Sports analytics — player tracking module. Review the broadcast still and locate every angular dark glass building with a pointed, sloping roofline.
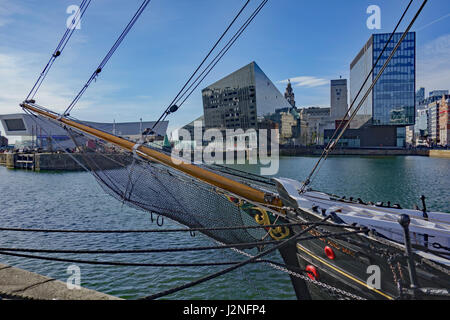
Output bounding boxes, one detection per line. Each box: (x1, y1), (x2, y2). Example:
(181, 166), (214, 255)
(202, 62), (292, 130)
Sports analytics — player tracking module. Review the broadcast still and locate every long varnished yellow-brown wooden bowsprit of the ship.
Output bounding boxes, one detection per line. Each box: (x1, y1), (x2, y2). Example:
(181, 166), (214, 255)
(21, 103), (282, 207)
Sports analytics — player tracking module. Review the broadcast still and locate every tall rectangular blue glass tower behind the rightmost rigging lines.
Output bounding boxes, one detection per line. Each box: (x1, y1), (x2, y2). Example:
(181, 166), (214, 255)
(350, 32), (416, 147)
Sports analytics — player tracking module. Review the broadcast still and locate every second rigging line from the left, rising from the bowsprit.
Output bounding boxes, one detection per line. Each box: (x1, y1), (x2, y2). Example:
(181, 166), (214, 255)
(63, 0), (151, 116)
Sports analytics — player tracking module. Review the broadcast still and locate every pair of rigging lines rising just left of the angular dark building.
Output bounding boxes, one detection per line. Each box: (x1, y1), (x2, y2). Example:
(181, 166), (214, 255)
(152, 0), (269, 130)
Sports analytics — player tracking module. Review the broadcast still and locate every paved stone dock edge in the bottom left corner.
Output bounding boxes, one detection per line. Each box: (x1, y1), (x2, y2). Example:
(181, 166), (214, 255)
(0, 263), (122, 300)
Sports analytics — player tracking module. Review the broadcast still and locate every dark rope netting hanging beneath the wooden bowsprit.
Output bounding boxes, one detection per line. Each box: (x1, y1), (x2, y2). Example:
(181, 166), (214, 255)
(25, 110), (284, 247)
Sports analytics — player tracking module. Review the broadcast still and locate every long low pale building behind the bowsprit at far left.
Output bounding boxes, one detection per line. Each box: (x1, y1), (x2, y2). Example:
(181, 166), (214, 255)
(0, 113), (169, 150)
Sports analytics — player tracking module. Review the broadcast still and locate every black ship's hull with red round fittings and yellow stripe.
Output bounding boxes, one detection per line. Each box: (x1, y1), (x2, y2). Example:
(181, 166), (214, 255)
(281, 212), (450, 300)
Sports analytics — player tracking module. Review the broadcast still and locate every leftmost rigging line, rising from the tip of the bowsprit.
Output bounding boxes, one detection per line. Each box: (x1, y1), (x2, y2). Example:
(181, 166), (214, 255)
(25, 0), (91, 101)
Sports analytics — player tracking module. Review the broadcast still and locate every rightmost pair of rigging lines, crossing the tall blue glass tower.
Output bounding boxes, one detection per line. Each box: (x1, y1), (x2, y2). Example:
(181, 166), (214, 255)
(301, 0), (428, 192)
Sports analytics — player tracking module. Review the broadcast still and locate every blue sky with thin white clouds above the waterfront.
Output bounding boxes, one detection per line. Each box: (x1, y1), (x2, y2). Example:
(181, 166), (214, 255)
(0, 0), (450, 138)
